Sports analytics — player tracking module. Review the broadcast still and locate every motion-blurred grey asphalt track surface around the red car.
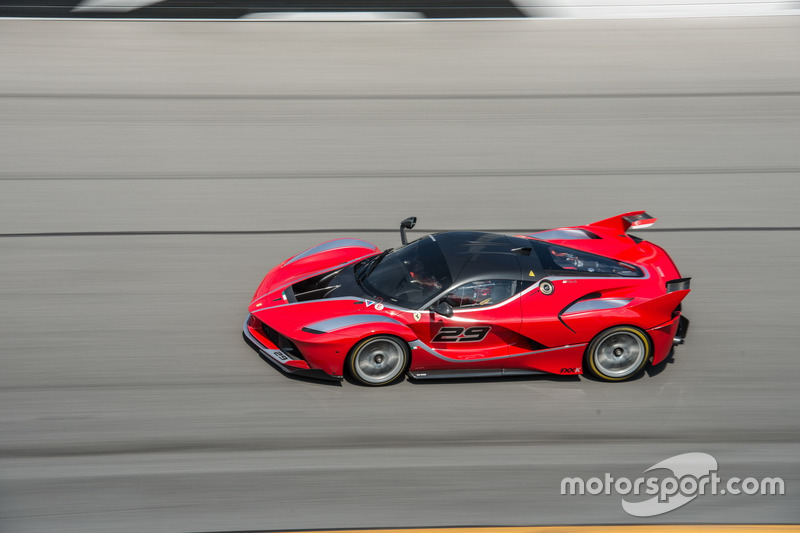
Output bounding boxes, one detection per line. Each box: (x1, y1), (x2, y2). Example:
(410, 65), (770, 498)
(0, 17), (800, 532)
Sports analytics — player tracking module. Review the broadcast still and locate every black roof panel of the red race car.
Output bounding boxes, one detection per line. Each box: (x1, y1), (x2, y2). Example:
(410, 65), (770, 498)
(425, 231), (538, 284)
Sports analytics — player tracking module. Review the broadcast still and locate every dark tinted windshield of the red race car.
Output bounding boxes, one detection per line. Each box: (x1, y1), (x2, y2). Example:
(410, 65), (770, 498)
(356, 236), (453, 309)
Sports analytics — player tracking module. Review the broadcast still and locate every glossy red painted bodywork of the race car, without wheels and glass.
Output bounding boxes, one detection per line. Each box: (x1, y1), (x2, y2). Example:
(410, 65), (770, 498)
(245, 212), (689, 384)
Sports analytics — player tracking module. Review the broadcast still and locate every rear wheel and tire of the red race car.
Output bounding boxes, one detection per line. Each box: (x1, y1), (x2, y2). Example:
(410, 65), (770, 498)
(584, 326), (653, 381)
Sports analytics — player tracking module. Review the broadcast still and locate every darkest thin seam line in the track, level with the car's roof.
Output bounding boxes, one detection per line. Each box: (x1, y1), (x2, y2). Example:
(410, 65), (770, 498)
(0, 226), (800, 238)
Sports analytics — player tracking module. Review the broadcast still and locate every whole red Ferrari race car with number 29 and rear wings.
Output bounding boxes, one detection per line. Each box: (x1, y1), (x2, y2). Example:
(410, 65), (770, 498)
(244, 211), (689, 385)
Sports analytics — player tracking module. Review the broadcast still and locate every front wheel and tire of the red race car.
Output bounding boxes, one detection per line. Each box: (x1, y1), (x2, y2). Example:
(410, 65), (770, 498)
(347, 335), (410, 387)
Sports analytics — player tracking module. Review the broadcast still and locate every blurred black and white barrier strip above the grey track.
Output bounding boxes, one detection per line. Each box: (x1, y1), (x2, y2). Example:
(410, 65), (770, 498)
(0, 0), (800, 20)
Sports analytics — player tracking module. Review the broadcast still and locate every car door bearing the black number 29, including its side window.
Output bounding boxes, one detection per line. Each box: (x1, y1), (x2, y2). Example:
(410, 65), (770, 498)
(411, 279), (521, 370)
